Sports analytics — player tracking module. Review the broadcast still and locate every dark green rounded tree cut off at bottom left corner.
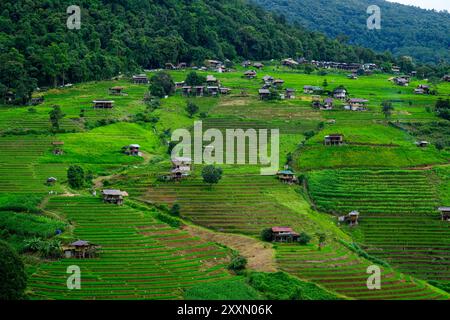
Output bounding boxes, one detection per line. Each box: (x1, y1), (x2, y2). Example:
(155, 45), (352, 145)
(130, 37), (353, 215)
(0, 240), (27, 300)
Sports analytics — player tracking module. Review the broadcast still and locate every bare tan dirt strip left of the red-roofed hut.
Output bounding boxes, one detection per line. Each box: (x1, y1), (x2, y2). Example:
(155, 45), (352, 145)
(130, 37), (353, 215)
(183, 225), (277, 272)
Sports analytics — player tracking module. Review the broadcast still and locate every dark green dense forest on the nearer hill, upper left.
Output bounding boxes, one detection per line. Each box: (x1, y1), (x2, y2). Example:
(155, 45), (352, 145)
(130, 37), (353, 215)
(0, 0), (396, 103)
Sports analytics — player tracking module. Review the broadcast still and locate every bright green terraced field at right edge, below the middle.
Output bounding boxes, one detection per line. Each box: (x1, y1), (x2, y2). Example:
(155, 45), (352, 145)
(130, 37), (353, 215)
(308, 170), (450, 281)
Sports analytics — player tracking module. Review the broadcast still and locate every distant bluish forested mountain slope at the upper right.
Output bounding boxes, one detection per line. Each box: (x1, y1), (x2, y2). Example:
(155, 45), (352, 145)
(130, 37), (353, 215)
(252, 0), (450, 63)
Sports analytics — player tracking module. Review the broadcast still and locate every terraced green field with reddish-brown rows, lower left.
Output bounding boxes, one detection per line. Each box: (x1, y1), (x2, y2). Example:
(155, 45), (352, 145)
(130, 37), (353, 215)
(29, 197), (231, 299)
